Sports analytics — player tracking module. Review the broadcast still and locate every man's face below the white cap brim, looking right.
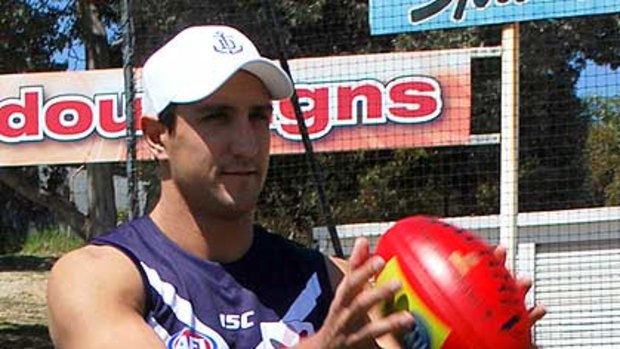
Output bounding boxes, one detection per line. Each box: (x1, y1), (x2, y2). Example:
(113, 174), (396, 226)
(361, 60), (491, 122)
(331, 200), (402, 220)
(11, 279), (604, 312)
(164, 71), (272, 217)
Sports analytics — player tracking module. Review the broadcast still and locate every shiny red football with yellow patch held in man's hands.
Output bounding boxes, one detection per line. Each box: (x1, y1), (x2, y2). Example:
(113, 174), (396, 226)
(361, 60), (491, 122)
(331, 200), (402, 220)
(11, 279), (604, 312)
(376, 216), (531, 349)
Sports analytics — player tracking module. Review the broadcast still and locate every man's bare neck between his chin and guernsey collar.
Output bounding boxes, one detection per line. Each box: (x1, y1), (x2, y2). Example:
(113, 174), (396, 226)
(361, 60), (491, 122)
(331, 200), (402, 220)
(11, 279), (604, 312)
(150, 189), (254, 263)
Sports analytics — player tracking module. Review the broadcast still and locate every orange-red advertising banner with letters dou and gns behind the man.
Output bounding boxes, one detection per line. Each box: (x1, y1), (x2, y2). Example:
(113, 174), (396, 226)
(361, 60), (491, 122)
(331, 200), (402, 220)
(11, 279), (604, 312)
(0, 50), (471, 166)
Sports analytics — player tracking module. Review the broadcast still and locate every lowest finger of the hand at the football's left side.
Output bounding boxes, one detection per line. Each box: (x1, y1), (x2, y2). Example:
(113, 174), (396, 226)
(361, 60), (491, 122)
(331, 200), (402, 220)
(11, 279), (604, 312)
(345, 311), (415, 348)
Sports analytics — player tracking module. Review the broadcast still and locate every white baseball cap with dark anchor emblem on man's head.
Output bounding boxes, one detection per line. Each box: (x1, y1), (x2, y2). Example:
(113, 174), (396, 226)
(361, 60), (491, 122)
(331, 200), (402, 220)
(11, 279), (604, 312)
(142, 25), (293, 118)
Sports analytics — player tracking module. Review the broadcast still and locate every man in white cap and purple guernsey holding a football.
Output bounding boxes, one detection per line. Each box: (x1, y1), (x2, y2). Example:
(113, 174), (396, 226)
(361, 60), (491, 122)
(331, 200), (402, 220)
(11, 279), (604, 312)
(48, 26), (544, 349)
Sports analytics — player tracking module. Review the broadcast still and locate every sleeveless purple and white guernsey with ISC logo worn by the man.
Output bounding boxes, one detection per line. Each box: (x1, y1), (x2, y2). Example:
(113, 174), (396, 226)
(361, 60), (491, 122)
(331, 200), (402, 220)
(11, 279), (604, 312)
(91, 217), (333, 349)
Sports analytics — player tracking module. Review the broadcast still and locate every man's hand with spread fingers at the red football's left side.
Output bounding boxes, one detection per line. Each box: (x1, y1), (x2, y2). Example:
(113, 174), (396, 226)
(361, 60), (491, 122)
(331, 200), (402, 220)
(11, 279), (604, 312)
(298, 238), (414, 349)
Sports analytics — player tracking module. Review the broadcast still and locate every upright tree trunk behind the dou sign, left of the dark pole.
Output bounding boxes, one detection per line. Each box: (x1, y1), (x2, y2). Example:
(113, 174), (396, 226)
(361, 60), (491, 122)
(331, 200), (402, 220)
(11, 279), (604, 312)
(77, 0), (116, 236)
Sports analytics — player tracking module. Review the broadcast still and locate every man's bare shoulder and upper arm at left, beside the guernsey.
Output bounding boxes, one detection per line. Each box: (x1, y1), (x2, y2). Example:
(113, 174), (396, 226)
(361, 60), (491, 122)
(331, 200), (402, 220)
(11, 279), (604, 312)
(47, 246), (164, 349)
